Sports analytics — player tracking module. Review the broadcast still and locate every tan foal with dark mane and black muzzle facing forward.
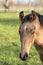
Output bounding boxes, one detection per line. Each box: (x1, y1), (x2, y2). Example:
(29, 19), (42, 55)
(19, 10), (43, 64)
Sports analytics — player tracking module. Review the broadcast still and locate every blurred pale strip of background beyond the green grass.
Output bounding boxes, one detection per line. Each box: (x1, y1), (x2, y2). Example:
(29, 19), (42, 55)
(0, 0), (43, 11)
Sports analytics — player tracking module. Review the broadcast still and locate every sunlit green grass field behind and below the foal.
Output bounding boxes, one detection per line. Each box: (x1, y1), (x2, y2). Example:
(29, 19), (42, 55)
(0, 13), (41, 65)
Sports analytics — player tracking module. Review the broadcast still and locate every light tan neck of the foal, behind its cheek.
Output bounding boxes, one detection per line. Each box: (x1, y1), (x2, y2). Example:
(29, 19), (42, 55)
(34, 18), (43, 47)
